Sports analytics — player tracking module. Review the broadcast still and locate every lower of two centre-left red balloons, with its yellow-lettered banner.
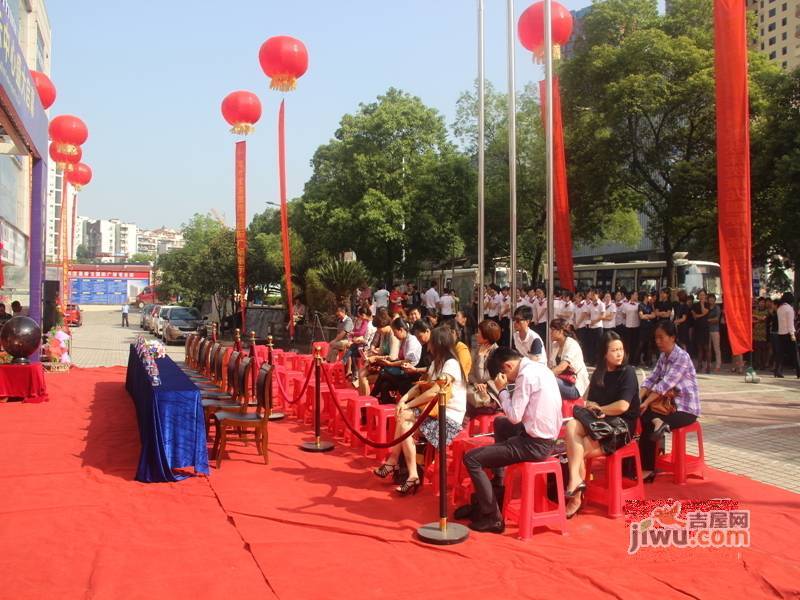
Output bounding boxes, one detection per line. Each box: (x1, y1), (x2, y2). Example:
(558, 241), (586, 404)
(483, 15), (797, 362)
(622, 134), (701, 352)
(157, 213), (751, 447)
(222, 90), (261, 329)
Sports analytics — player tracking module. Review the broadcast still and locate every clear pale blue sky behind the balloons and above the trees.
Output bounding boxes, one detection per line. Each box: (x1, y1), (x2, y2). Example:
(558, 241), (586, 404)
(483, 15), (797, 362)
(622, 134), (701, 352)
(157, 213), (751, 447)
(48, 0), (590, 228)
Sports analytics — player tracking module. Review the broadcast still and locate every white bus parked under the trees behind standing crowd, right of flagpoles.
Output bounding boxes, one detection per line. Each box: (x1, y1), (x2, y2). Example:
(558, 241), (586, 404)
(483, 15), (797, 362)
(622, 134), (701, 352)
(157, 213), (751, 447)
(556, 258), (722, 302)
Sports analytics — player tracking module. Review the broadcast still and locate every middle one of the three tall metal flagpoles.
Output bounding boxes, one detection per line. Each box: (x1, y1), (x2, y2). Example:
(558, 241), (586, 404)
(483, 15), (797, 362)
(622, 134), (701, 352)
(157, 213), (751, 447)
(507, 0), (517, 347)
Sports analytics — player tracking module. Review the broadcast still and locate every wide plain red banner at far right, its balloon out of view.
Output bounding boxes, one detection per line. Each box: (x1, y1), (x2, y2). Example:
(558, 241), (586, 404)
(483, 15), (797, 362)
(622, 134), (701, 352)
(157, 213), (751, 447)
(714, 0), (753, 355)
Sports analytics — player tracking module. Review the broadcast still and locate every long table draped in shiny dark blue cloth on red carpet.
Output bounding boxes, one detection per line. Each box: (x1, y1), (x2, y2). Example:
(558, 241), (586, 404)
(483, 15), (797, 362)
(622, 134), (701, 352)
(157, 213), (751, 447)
(125, 345), (208, 483)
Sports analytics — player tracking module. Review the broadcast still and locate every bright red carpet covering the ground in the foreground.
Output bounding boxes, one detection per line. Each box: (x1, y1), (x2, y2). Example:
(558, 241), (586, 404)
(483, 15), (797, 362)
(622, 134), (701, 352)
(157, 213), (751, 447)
(0, 368), (800, 600)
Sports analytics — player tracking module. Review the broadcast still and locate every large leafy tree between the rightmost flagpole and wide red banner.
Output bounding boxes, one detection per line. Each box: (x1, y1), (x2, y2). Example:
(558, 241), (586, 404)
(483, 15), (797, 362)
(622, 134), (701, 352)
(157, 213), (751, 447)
(561, 0), (774, 278)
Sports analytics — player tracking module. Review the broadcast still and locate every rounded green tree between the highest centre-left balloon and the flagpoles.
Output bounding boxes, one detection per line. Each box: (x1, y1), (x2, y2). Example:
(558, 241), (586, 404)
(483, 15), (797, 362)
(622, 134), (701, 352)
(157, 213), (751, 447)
(292, 89), (473, 281)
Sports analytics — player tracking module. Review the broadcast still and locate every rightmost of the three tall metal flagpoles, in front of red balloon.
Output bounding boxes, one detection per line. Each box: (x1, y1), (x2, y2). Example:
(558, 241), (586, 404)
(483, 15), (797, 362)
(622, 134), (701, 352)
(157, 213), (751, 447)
(544, 0), (556, 356)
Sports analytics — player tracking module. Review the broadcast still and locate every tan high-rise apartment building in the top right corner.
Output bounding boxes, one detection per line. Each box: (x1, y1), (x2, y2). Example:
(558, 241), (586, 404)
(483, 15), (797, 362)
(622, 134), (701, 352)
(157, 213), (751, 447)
(747, 0), (800, 71)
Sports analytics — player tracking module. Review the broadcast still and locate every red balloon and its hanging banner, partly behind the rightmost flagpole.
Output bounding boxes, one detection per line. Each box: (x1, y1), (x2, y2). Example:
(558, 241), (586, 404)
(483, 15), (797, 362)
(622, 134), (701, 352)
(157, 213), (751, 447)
(517, 1), (575, 298)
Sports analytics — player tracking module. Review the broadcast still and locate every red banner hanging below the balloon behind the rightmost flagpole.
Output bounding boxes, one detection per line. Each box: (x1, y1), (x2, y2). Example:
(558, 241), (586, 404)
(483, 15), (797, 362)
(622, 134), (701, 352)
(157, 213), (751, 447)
(539, 77), (575, 292)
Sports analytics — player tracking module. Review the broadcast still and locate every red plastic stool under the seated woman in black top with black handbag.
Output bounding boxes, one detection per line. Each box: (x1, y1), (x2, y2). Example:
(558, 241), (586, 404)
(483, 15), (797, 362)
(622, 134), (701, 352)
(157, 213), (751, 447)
(585, 440), (644, 518)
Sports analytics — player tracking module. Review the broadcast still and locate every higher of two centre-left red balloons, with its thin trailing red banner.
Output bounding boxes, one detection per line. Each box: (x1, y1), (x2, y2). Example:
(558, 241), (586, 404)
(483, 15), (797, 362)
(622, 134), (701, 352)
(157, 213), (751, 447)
(258, 35), (308, 339)
